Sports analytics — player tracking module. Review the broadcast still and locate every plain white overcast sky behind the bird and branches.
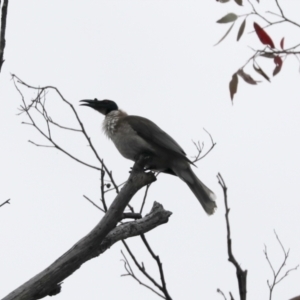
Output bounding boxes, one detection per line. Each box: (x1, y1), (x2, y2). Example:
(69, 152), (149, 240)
(0, 0), (300, 300)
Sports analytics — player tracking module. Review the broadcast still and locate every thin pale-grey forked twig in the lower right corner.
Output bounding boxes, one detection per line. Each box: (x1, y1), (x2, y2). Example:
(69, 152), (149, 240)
(264, 230), (299, 300)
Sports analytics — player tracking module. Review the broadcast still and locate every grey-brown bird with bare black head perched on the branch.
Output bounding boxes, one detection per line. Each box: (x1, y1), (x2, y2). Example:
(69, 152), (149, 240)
(80, 99), (217, 215)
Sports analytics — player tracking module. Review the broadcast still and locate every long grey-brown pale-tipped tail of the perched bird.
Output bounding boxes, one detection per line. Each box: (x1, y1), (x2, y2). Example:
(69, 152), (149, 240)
(174, 167), (217, 215)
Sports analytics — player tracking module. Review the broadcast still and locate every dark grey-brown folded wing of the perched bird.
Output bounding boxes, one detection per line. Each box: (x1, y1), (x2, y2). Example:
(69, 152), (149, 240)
(124, 116), (187, 159)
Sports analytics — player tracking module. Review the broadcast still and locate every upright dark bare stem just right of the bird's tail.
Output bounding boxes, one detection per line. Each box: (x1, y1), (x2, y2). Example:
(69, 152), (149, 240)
(217, 173), (247, 300)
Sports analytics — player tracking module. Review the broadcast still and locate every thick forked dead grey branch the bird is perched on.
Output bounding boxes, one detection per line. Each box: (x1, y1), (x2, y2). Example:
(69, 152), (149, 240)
(3, 166), (171, 300)
